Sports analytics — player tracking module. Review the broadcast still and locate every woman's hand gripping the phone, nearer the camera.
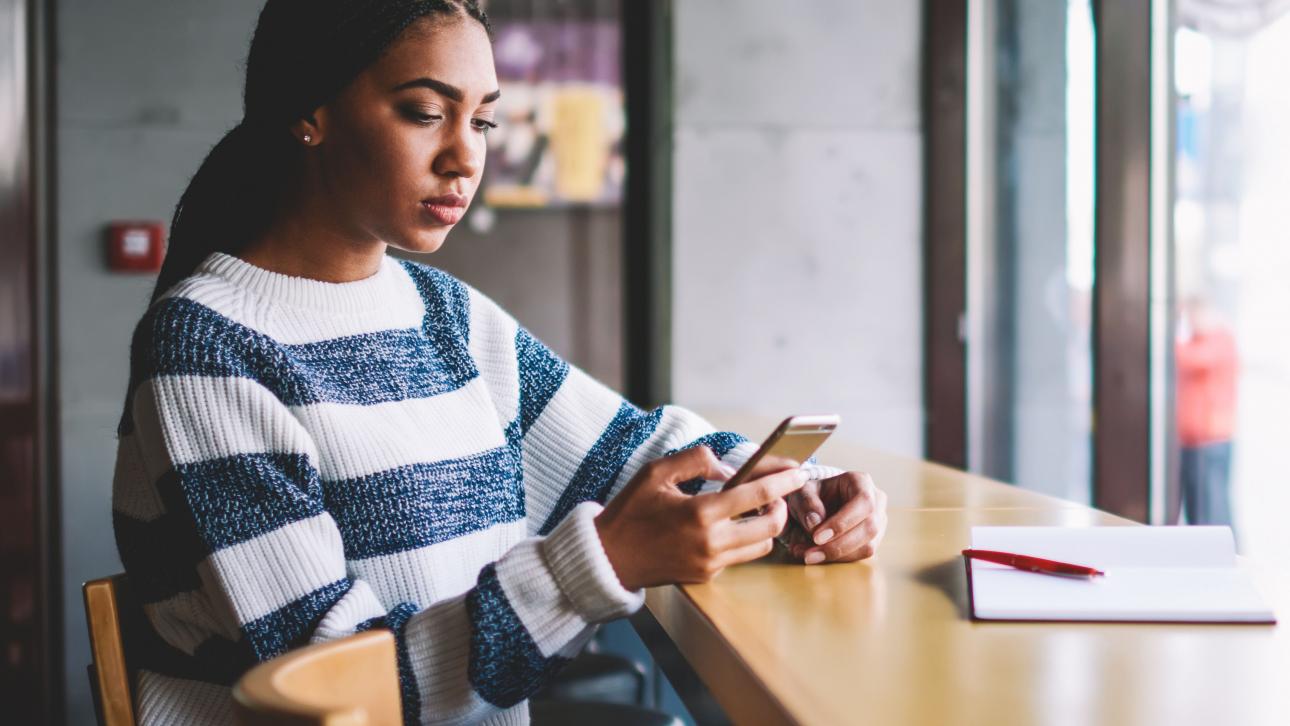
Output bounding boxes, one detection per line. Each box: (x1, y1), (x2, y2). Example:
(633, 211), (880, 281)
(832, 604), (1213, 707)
(596, 446), (806, 589)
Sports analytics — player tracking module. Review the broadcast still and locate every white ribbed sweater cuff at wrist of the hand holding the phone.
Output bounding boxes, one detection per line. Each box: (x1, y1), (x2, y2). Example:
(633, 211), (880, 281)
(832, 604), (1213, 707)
(542, 502), (645, 623)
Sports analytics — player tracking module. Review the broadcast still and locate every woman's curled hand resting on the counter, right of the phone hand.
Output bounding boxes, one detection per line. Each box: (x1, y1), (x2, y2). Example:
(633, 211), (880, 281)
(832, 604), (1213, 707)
(784, 472), (888, 565)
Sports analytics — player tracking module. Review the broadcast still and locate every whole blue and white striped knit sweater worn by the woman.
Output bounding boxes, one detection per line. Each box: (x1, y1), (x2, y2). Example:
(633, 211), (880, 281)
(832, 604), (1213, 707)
(114, 253), (836, 725)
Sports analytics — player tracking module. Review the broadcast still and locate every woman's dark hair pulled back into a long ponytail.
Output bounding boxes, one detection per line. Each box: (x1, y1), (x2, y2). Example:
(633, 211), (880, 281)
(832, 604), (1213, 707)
(152, 0), (491, 302)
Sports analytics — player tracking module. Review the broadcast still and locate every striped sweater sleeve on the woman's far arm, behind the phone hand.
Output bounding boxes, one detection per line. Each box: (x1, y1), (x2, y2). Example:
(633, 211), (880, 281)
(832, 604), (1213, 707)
(468, 281), (841, 534)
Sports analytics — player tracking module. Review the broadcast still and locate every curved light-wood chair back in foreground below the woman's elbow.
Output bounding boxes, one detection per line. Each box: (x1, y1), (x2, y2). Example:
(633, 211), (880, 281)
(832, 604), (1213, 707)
(233, 629), (402, 726)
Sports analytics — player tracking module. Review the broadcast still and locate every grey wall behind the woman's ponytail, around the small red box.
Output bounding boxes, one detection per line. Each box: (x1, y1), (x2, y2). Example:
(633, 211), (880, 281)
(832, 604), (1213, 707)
(55, 0), (262, 723)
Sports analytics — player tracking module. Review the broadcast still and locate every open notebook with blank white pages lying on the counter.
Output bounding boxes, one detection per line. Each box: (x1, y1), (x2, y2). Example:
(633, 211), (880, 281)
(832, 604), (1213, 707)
(965, 526), (1276, 623)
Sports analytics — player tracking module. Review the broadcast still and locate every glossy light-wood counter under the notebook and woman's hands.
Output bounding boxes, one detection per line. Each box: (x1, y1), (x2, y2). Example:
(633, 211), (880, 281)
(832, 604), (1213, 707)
(637, 415), (1290, 726)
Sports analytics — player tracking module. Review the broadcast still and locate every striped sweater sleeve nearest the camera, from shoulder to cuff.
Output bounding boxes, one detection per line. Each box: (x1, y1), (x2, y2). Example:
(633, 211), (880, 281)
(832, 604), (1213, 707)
(114, 297), (641, 722)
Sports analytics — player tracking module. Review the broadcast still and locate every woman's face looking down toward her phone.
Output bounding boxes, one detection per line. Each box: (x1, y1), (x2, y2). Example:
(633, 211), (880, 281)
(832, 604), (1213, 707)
(310, 17), (498, 253)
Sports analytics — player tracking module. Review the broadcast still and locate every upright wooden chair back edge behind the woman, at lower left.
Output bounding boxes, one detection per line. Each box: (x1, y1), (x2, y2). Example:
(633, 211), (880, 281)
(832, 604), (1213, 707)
(81, 574), (135, 726)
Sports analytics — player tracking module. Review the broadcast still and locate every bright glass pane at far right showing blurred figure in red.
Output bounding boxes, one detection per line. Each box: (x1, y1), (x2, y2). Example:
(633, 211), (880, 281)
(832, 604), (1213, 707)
(1167, 0), (1290, 560)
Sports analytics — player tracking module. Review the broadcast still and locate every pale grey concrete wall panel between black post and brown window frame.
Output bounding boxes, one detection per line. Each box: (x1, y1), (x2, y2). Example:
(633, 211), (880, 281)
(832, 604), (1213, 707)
(672, 0), (922, 454)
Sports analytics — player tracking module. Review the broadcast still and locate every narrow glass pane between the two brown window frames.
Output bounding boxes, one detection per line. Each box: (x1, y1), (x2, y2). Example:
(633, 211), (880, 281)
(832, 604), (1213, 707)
(965, 0), (1094, 502)
